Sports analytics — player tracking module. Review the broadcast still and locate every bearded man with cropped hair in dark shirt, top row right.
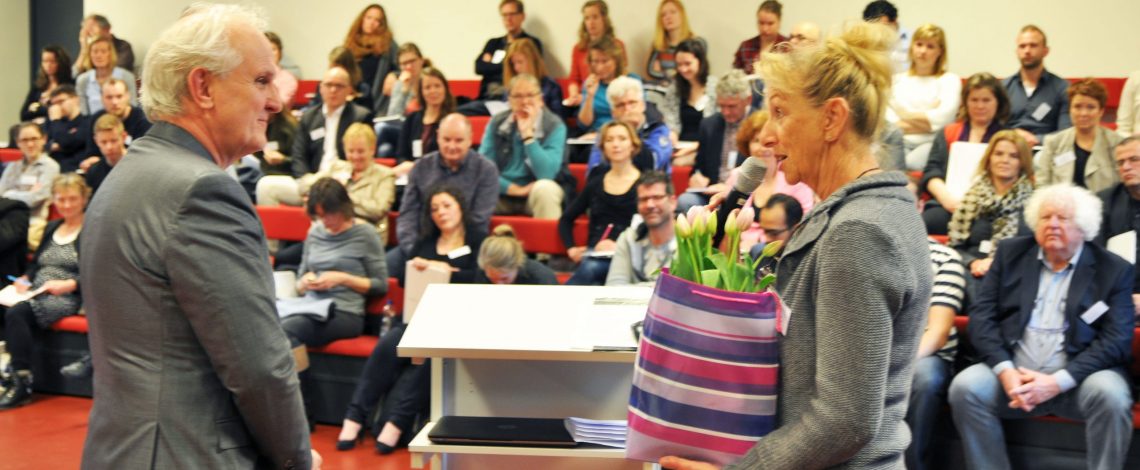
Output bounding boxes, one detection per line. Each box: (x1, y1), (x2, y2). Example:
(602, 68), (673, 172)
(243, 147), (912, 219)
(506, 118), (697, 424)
(1002, 24), (1073, 147)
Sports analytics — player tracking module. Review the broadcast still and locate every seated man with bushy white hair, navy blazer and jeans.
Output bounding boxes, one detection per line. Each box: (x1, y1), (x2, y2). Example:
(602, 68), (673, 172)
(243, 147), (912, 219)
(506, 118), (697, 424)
(950, 184), (1133, 469)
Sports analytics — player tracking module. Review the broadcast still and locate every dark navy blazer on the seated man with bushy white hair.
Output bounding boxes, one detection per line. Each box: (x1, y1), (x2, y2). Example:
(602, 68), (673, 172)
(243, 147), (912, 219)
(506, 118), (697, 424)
(968, 236), (1134, 383)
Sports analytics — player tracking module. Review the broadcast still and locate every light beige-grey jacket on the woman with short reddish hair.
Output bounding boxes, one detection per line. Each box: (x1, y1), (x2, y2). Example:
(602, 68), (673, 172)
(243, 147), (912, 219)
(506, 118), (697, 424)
(1036, 127), (1121, 193)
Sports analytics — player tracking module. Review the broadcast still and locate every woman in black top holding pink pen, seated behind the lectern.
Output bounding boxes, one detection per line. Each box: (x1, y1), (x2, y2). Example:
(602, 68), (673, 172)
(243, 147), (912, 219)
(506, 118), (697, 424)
(559, 121), (642, 285)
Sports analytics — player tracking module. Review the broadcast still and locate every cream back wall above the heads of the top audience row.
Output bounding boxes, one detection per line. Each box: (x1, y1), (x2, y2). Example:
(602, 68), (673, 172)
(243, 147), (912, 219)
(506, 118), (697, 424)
(71, 0), (1140, 81)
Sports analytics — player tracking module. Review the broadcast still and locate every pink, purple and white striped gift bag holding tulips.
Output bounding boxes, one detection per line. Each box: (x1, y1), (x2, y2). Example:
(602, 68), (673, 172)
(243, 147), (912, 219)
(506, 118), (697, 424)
(626, 273), (780, 465)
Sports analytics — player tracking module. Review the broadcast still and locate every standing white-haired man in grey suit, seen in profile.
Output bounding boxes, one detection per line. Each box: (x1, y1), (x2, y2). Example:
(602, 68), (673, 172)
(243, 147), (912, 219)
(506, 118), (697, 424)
(80, 5), (320, 469)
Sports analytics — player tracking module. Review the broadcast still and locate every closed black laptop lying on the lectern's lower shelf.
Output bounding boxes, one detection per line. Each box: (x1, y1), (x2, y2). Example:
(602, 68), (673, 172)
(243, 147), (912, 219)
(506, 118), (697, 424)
(428, 416), (577, 447)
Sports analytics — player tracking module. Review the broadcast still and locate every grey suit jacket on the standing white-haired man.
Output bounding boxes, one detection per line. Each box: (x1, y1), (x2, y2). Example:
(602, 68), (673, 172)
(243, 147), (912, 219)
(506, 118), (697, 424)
(80, 122), (311, 469)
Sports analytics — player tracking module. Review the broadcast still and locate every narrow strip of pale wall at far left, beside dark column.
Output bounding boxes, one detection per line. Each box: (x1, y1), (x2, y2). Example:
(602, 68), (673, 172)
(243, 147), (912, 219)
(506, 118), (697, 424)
(0, 1), (32, 140)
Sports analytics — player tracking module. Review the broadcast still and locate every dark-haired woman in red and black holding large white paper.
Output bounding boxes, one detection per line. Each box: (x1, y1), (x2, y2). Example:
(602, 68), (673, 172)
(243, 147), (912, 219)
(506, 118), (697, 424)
(919, 72), (1010, 235)
